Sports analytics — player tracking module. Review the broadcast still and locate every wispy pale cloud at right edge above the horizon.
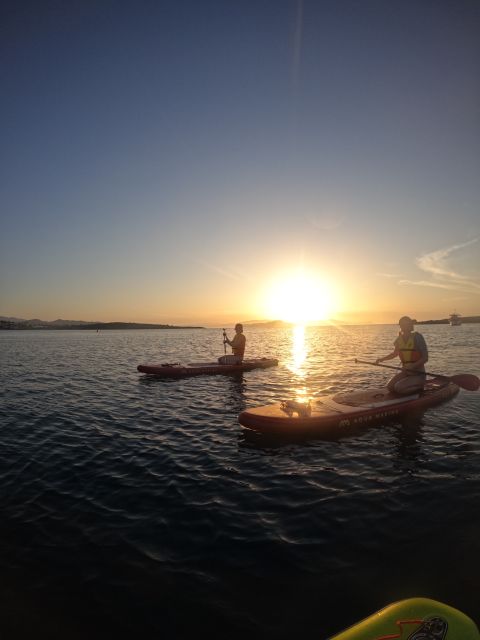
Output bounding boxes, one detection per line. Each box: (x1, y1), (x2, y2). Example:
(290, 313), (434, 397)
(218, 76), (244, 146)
(399, 238), (480, 293)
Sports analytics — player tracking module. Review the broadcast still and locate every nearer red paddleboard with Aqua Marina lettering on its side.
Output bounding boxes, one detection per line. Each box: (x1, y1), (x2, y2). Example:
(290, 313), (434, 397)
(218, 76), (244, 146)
(238, 378), (460, 437)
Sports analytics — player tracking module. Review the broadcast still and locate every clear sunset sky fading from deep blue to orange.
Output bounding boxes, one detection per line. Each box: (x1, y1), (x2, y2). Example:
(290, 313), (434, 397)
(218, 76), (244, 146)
(0, 0), (480, 326)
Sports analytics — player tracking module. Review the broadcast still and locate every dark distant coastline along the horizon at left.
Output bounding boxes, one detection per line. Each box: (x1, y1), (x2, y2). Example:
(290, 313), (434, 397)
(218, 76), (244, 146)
(0, 317), (204, 331)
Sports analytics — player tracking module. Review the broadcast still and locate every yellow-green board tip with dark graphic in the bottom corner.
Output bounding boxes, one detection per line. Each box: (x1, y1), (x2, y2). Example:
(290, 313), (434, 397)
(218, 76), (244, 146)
(330, 598), (480, 640)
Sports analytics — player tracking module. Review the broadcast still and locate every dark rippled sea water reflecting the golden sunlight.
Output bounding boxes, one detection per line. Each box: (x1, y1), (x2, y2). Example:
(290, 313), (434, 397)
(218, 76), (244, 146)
(0, 325), (480, 640)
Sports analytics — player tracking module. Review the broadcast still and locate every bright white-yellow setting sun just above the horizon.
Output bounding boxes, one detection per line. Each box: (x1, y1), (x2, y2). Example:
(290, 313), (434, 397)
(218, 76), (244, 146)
(265, 271), (335, 324)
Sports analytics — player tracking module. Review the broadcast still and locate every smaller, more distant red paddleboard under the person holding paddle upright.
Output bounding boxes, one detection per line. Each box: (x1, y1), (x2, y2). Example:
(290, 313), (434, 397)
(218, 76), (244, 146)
(137, 358), (278, 378)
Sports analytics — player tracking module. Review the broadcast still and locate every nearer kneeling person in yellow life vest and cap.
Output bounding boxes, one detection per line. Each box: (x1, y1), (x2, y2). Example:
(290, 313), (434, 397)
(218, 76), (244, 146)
(376, 316), (428, 395)
